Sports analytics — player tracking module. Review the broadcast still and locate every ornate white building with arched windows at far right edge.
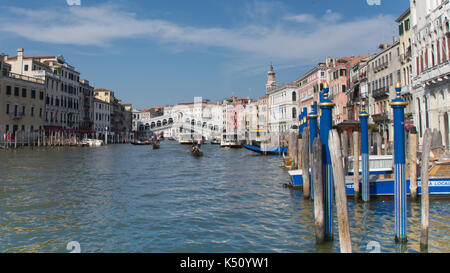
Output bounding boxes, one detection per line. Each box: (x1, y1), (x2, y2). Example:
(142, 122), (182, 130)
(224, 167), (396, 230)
(410, 0), (450, 148)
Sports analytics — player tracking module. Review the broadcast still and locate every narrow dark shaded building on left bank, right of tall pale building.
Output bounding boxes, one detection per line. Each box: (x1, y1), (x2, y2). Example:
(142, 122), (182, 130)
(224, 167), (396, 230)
(80, 80), (94, 132)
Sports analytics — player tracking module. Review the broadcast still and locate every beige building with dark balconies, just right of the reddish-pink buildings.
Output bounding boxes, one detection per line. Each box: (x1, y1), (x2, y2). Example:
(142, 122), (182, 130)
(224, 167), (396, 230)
(367, 37), (401, 144)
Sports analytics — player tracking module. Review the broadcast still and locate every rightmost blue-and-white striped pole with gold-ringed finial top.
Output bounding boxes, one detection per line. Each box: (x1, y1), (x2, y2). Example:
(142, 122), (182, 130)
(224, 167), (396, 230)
(390, 83), (408, 242)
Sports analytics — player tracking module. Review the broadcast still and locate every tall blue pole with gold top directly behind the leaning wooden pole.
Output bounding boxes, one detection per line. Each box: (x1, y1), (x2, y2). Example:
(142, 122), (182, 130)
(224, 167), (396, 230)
(319, 83), (335, 240)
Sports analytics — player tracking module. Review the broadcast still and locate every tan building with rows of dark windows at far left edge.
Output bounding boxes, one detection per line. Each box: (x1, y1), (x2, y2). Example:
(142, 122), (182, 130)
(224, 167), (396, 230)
(0, 55), (45, 138)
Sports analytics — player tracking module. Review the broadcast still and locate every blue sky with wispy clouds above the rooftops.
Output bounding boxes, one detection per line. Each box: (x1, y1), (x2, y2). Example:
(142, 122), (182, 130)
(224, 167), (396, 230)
(0, 0), (409, 109)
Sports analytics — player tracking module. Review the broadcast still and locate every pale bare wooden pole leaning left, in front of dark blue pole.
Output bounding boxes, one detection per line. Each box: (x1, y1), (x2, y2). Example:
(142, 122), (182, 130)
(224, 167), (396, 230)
(328, 129), (356, 253)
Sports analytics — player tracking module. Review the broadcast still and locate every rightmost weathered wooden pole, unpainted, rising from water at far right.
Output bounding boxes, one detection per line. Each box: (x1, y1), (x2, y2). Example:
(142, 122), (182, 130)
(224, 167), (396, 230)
(420, 129), (432, 251)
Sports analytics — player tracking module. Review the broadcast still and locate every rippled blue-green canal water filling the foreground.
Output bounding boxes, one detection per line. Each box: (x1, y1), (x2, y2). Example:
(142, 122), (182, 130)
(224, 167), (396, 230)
(0, 141), (450, 253)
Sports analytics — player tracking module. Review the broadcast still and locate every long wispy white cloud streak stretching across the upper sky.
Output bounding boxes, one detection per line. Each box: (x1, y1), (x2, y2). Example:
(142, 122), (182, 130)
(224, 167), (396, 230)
(0, 4), (395, 61)
